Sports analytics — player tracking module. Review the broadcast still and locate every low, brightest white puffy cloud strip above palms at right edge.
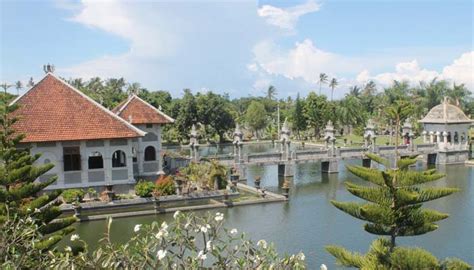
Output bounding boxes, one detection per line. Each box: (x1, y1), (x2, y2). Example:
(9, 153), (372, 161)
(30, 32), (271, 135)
(356, 51), (474, 88)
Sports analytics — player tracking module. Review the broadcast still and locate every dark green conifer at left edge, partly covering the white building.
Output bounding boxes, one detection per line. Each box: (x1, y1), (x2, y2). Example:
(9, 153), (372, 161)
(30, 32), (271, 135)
(0, 85), (76, 250)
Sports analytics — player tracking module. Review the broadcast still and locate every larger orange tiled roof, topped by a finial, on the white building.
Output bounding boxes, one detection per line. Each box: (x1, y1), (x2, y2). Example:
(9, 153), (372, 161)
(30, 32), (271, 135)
(12, 73), (145, 142)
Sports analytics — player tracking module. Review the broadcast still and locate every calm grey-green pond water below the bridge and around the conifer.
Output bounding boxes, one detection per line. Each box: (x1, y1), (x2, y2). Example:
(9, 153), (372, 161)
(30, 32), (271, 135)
(71, 144), (474, 269)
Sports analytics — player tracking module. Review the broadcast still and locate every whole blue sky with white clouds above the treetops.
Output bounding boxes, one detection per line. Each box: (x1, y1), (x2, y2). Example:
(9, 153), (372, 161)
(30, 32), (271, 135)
(0, 0), (474, 98)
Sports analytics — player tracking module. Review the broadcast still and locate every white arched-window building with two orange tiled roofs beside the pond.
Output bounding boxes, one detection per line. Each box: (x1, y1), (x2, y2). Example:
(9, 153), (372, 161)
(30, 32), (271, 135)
(13, 73), (173, 189)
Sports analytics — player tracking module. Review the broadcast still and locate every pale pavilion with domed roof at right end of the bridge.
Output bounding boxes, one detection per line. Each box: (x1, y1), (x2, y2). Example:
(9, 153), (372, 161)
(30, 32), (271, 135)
(420, 98), (474, 164)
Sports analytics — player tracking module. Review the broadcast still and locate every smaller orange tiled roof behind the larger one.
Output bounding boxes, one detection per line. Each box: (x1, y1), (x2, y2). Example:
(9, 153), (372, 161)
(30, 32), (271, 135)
(112, 95), (174, 124)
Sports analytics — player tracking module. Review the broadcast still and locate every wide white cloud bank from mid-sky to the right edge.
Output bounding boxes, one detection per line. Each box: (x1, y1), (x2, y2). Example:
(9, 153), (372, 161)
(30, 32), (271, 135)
(248, 39), (474, 96)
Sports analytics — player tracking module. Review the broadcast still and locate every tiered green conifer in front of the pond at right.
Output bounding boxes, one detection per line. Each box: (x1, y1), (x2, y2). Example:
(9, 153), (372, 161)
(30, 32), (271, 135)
(326, 98), (470, 269)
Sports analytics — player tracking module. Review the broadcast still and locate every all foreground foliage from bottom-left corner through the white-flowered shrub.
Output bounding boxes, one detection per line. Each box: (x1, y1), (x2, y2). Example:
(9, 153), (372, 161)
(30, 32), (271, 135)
(0, 211), (305, 269)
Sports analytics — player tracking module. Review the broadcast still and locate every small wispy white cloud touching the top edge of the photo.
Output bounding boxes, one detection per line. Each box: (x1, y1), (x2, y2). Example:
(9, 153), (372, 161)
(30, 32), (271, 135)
(257, 0), (320, 30)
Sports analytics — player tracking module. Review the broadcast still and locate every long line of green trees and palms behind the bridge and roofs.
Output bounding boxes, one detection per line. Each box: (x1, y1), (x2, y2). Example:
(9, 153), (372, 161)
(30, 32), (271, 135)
(8, 73), (474, 143)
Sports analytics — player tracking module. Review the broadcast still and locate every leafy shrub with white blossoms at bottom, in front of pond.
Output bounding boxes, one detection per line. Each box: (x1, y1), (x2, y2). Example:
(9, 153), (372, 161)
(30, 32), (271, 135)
(49, 211), (305, 269)
